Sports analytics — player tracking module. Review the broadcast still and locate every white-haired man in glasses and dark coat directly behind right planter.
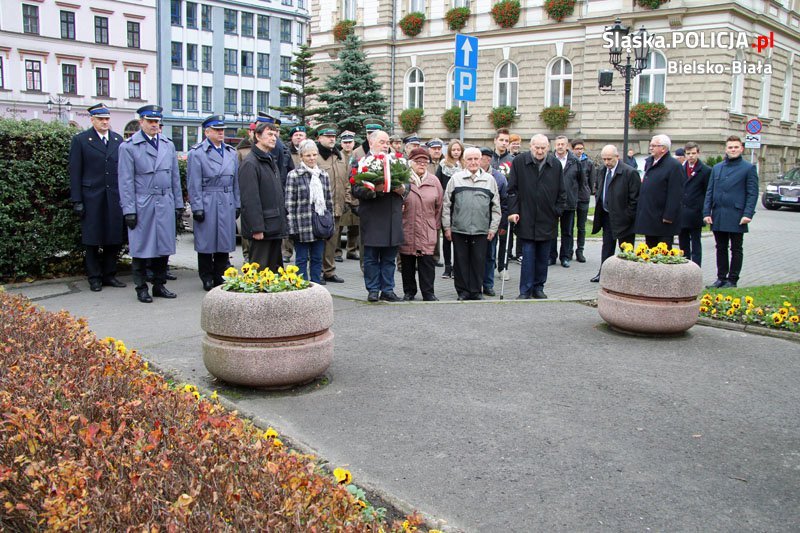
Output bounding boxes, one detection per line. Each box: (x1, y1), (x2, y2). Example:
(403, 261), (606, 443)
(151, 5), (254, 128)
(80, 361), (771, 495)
(636, 135), (683, 248)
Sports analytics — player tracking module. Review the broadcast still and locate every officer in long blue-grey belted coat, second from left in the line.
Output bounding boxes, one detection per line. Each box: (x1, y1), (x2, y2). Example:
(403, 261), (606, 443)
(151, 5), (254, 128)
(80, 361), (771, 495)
(118, 105), (183, 303)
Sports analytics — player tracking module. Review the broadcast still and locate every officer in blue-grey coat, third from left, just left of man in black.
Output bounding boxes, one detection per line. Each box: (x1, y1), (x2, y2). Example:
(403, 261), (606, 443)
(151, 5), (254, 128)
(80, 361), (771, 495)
(186, 115), (241, 291)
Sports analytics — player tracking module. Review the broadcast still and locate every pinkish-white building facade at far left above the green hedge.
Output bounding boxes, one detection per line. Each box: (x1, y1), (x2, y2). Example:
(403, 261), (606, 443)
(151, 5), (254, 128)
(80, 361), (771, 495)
(0, 0), (157, 133)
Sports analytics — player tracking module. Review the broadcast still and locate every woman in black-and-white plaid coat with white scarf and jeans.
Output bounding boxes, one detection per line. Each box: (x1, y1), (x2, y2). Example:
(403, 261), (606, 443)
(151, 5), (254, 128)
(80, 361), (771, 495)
(286, 140), (333, 285)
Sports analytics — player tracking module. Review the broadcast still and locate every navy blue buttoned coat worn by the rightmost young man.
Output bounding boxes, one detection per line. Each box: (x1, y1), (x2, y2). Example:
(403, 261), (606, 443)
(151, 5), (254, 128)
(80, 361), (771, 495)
(703, 156), (758, 233)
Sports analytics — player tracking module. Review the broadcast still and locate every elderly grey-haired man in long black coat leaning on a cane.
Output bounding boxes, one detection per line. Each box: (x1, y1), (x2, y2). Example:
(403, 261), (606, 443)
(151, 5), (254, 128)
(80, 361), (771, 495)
(508, 135), (567, 299)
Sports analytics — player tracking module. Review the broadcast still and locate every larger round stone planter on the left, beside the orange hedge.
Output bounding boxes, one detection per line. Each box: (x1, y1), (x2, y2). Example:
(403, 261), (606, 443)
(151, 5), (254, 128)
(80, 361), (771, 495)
(200, 284), (333, 388)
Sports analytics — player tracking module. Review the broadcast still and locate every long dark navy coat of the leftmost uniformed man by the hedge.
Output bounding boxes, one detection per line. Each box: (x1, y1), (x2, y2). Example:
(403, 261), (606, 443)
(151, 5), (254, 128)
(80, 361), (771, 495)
(69, 128), (125, 246)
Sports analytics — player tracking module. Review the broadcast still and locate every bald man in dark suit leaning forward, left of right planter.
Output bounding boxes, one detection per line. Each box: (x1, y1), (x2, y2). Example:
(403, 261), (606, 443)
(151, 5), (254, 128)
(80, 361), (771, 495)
(590, 144), (642, 283)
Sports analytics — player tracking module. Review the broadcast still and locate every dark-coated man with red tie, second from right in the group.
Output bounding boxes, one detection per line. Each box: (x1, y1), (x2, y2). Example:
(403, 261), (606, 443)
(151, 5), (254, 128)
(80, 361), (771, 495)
(678, 142), (711, 266)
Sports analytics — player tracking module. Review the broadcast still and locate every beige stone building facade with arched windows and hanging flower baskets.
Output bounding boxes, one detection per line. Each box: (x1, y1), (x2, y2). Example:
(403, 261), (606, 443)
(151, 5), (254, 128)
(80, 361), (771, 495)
(311, 0), (800, 180)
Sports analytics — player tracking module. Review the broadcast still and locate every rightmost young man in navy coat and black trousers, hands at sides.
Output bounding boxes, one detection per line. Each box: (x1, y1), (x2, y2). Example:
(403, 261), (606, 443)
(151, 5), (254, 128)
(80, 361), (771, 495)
(703, 135), (758, 288)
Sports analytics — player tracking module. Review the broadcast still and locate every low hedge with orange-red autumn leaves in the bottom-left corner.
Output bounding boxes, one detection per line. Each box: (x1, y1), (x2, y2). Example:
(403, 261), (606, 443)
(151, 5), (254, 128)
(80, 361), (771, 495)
(0, 292), (420, 531)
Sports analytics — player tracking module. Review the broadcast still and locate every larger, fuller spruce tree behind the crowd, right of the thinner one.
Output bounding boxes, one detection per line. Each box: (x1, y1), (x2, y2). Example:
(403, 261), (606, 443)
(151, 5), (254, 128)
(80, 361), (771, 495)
(319, 34), (388, 133)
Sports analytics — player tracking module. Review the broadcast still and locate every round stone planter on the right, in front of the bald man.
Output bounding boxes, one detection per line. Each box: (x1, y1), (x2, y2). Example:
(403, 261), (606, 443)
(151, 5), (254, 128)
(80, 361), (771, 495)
(597, 256), (703, 335)
